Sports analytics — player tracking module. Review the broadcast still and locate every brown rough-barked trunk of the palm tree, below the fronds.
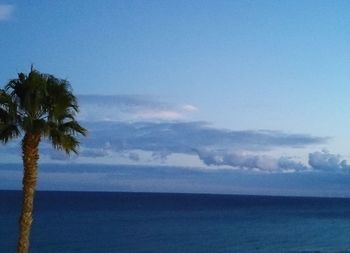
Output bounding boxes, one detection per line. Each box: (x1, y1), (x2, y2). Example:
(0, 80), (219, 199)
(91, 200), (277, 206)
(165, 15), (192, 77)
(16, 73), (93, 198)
(17, 133), (40, 253)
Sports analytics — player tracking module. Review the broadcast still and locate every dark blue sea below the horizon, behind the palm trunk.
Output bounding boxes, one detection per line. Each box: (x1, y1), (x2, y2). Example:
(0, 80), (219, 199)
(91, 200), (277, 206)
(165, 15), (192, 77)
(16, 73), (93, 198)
(0, 191), (350, 253)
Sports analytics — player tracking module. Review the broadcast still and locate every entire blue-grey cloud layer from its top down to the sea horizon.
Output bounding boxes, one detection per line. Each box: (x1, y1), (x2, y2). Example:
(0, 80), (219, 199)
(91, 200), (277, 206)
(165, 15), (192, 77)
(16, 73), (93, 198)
(0, 95), (350, 196)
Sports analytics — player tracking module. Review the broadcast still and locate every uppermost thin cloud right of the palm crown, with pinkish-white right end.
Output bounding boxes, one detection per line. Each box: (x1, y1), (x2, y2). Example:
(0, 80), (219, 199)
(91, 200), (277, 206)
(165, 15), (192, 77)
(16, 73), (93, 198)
(79, 95), (198, 121)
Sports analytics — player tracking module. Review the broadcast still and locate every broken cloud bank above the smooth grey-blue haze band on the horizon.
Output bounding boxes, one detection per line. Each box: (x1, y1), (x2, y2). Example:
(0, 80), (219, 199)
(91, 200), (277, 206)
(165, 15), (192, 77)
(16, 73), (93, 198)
(1, 95), (350, 172)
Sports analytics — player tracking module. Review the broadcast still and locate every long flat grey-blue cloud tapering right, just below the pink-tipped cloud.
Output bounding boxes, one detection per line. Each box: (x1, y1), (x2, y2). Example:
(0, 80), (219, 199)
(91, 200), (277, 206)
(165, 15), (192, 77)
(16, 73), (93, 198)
(82, 122), (327, 154)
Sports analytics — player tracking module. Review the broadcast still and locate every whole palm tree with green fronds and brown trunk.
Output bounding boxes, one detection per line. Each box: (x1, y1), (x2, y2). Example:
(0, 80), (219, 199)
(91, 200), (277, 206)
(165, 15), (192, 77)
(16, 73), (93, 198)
(0, 66), (86, 253)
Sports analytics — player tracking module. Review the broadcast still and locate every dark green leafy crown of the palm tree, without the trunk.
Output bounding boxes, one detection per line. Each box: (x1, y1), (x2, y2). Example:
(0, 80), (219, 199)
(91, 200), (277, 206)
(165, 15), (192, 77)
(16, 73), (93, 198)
(0, 67), (87, 153)
